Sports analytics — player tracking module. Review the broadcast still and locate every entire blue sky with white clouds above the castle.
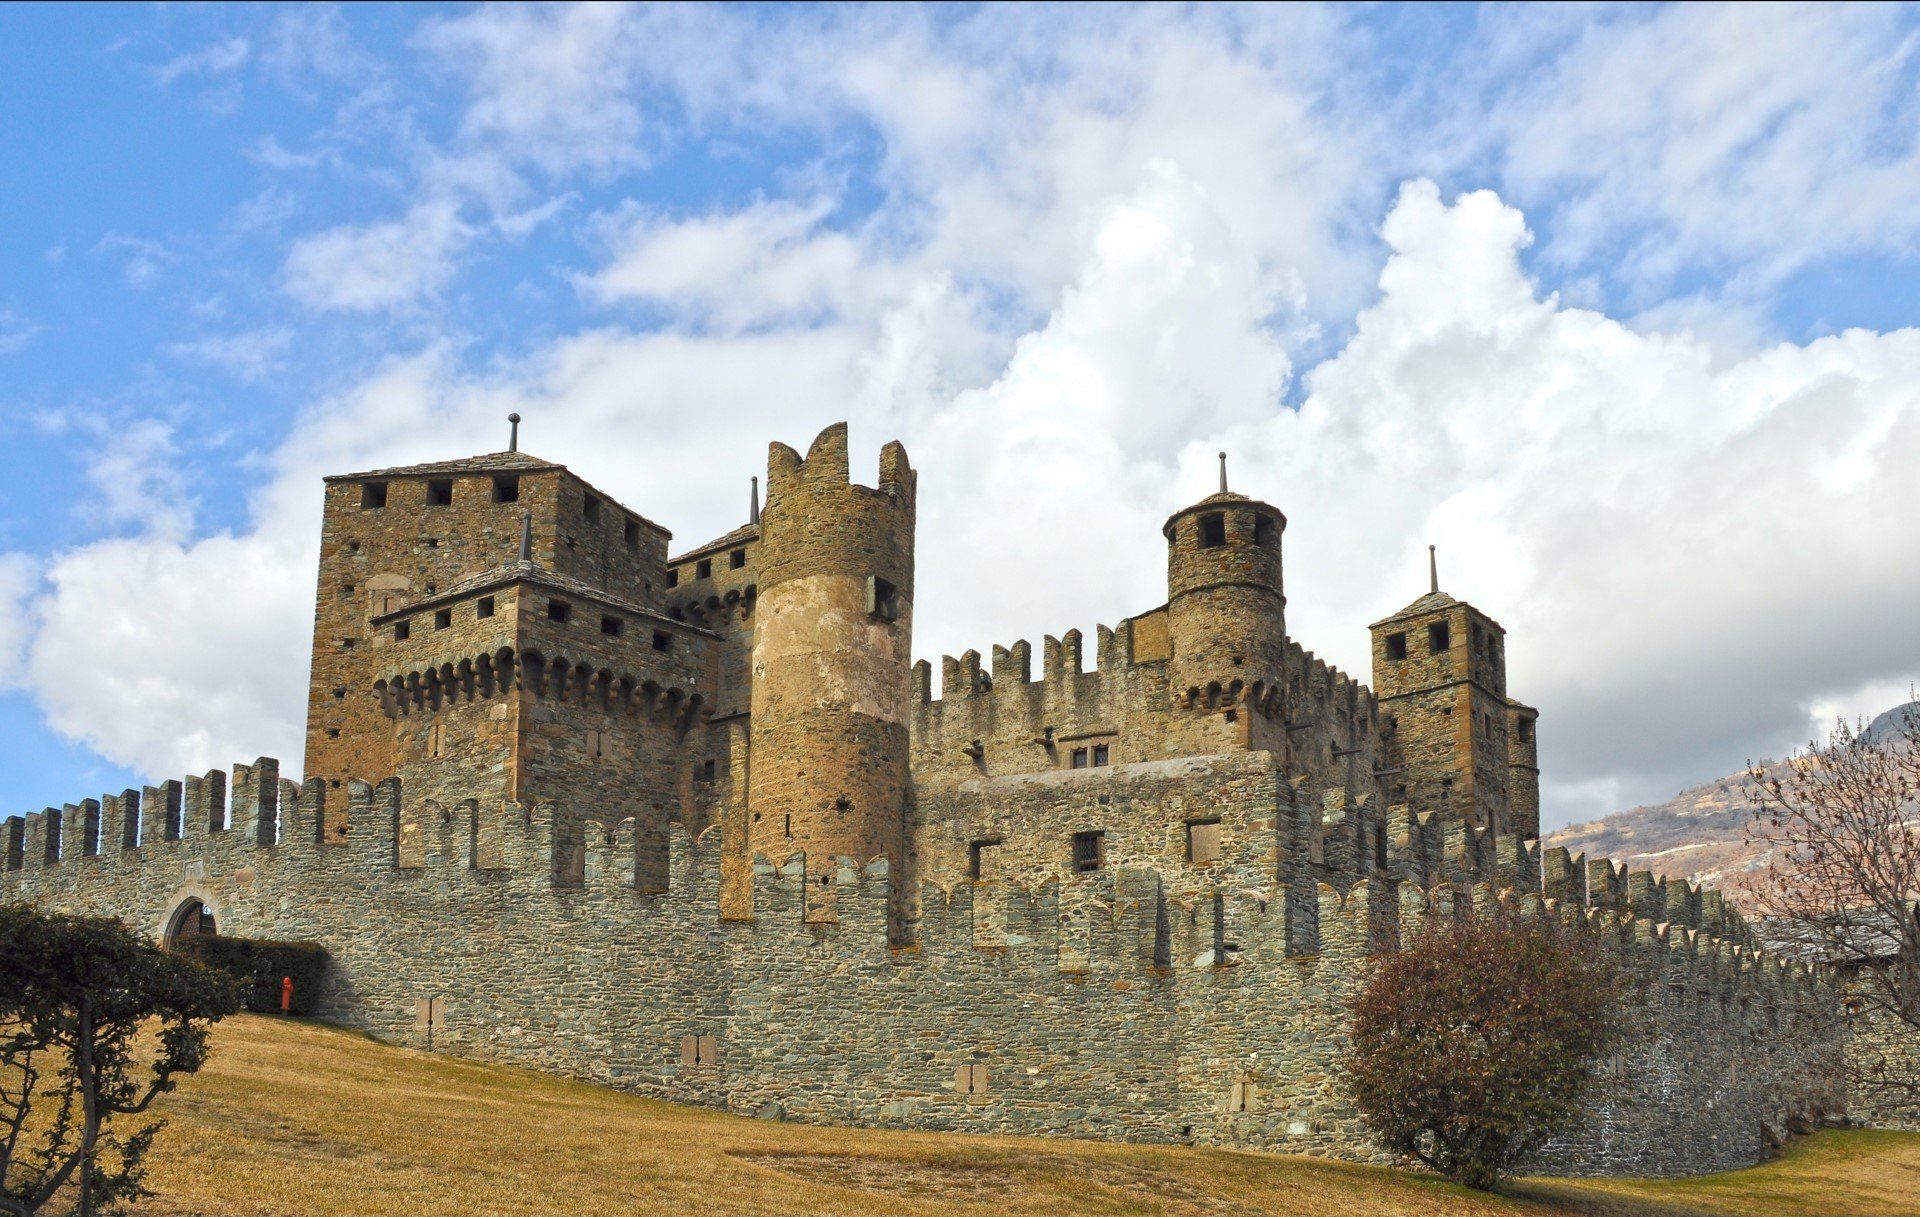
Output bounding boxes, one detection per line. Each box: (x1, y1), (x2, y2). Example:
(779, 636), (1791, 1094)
(0, 6), (1920, 822)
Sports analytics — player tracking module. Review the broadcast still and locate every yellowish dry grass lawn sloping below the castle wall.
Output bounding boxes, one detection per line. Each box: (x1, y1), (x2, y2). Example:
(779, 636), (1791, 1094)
(123, 1015), (1920, 1217)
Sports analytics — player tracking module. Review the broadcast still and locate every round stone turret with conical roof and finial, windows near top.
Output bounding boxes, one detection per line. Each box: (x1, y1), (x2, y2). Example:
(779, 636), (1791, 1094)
(1162, 457), (1286, 749)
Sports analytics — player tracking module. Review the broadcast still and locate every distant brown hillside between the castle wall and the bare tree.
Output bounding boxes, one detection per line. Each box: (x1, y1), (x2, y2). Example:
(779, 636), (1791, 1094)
(1546, 704), (1910, 900)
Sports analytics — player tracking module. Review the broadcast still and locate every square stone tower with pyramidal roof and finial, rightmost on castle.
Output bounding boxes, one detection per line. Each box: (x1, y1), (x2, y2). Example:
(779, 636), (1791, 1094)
(1369, 557), (1515, 831)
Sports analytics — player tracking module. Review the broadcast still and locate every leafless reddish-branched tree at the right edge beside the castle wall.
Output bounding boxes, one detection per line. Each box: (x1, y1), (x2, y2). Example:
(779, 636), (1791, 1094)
(1747, 701), (1920, 1113)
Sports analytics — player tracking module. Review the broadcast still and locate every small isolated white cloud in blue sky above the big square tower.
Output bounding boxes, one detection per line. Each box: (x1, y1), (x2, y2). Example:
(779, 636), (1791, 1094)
(280, 202), (472, 313)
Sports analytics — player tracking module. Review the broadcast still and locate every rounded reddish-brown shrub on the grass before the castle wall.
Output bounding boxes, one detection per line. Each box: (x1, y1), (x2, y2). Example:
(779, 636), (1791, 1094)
(1346, 908), (1624, 1190)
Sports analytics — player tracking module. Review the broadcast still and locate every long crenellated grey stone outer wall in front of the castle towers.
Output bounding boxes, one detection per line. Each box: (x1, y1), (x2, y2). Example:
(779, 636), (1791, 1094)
(0, 756), (1839, 1175)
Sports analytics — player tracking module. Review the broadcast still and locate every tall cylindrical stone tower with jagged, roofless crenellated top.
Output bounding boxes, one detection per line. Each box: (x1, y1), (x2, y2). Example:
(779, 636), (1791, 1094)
(747, 422), (914, 908)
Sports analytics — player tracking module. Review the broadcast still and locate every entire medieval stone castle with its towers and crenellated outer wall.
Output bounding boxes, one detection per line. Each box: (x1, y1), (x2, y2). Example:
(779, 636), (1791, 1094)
(0, 426), (1845, 1173)
